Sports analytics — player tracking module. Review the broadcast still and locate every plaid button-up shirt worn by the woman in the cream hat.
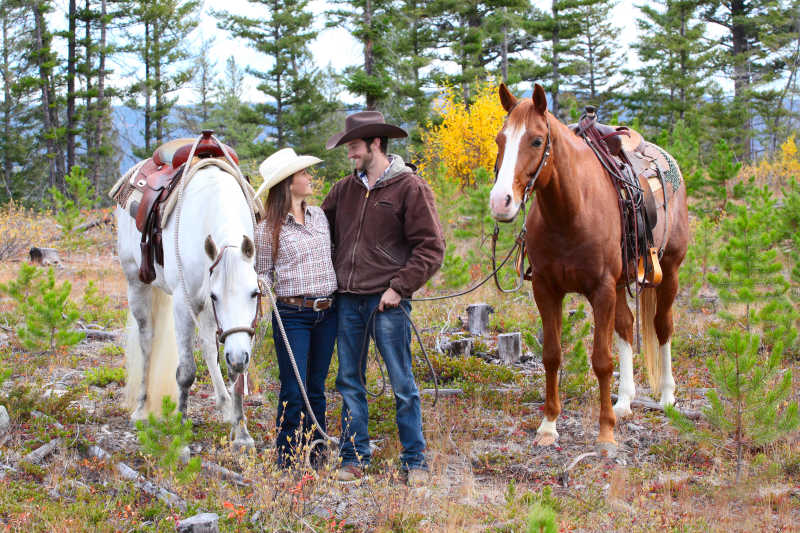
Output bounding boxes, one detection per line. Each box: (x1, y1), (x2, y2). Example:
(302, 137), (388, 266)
(255, 206), (337, 298)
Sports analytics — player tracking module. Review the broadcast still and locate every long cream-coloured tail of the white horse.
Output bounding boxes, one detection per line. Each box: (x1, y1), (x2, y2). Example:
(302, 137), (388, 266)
(125, 287), (178, 415)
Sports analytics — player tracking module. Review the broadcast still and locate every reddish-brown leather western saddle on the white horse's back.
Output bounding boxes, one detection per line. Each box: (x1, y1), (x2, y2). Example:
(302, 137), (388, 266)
(113, 130), (239, 283)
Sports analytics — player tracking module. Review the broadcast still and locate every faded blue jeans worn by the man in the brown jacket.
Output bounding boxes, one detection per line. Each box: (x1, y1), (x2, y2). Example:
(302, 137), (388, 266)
(336, 293), (427, 470)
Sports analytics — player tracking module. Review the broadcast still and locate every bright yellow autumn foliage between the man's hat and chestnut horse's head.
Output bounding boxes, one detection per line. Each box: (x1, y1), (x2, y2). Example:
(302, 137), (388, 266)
(417, 82), (505, 188)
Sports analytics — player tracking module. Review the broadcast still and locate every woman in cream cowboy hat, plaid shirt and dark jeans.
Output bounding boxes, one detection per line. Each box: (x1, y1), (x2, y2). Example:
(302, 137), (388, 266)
(255, 148), (336, 467)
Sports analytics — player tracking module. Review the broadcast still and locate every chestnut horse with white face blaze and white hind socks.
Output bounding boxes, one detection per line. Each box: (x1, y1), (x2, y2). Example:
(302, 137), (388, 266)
(489, 84), (689, 447)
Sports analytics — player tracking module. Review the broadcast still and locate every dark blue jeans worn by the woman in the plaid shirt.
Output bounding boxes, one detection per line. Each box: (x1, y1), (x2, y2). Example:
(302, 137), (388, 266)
(272, 302), (337, 466)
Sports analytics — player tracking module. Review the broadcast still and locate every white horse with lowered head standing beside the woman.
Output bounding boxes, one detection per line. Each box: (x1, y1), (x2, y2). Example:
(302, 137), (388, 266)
(116, 161), (259, 447)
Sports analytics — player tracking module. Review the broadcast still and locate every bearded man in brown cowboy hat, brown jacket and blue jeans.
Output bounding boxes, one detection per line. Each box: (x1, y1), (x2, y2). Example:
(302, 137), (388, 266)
(322, 111), (445, 485)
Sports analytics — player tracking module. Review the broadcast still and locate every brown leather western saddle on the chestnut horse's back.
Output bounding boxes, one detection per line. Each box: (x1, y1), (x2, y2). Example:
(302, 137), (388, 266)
(571, 106), (668, 286)
